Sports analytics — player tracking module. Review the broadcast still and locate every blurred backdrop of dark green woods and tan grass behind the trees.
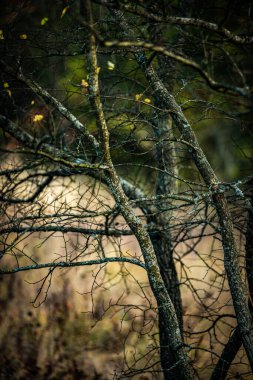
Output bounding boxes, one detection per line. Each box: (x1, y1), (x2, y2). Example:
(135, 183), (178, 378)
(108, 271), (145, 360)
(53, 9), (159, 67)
(0, 0), (253, 380)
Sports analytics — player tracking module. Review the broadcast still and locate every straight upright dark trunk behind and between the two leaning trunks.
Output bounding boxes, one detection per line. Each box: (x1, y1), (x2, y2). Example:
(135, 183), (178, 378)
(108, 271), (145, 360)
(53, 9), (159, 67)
(148, 18), (183, 374)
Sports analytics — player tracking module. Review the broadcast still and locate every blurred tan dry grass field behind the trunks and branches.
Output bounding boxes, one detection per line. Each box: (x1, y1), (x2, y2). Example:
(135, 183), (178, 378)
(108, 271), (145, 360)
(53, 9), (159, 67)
(0, 174), (252, 380)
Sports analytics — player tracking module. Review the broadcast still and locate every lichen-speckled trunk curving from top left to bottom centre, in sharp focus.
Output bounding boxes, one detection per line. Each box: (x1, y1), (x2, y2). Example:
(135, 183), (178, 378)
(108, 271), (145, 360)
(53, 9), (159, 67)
(83, 0), (192, 380)
